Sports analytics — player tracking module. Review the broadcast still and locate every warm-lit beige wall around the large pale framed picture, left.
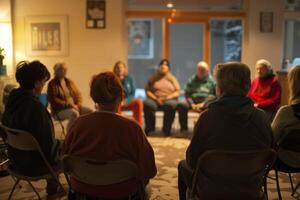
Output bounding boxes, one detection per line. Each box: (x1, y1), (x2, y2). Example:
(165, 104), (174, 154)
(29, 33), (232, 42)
(13, 0), (127, 106)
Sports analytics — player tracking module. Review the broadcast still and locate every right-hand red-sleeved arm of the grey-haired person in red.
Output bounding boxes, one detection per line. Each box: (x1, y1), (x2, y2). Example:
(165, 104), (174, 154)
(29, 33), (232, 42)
(256, 81), (281, 108)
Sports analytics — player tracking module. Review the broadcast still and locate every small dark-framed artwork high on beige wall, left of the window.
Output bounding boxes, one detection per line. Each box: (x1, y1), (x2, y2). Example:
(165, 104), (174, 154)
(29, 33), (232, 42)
(86, 0), (106, 29)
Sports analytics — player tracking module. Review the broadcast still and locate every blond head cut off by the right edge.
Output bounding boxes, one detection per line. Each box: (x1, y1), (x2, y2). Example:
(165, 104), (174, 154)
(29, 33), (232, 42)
(288, 65), (300, 104)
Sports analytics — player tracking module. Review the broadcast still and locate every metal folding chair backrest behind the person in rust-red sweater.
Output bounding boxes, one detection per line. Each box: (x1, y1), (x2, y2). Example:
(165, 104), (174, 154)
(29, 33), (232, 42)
(62, 155), (138, 185)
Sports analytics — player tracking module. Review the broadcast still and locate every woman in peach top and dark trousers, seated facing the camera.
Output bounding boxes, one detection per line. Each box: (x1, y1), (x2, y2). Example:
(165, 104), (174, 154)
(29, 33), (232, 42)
(144, 59), (180, 136)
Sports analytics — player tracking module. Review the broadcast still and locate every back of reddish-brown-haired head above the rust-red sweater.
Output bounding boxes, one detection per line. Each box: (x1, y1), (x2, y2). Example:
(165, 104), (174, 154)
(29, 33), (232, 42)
(90, 72), (123, 105)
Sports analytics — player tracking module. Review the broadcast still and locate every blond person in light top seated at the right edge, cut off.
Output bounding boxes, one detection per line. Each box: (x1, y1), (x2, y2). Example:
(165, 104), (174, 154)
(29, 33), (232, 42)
(272, 65), (300, 168)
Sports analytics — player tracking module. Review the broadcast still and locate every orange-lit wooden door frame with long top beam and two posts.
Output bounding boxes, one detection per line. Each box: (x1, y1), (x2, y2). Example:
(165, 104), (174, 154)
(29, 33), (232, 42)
(126, 9), (246, 63)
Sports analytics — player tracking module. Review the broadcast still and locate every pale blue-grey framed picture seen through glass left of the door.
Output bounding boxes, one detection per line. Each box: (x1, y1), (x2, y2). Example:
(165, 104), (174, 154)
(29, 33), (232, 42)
(128, 19), (154, 59)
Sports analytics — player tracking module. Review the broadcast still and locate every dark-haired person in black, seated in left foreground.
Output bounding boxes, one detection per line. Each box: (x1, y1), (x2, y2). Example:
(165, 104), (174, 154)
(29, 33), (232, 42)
(2, 61), (59, 195)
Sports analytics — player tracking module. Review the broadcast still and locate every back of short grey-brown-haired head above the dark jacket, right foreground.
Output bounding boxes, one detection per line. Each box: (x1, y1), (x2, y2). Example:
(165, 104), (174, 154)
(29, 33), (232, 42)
(214, 62), (251, 96)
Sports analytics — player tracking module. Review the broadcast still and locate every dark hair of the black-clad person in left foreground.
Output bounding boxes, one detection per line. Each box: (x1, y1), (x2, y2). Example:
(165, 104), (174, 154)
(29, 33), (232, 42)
(16, 60), (50, 89)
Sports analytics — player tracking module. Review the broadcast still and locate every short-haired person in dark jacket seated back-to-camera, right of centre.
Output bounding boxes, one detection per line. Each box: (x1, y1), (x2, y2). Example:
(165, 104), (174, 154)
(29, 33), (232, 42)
(178, 62), (273, 200)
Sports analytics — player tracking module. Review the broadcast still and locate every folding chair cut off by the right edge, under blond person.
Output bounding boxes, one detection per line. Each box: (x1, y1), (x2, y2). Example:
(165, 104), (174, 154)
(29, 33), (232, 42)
(274, 128), (300, 200)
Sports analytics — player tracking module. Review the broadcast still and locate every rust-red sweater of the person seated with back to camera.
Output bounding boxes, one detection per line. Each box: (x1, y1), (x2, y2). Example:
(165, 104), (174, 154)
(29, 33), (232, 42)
(63, 112), (156, 198)
